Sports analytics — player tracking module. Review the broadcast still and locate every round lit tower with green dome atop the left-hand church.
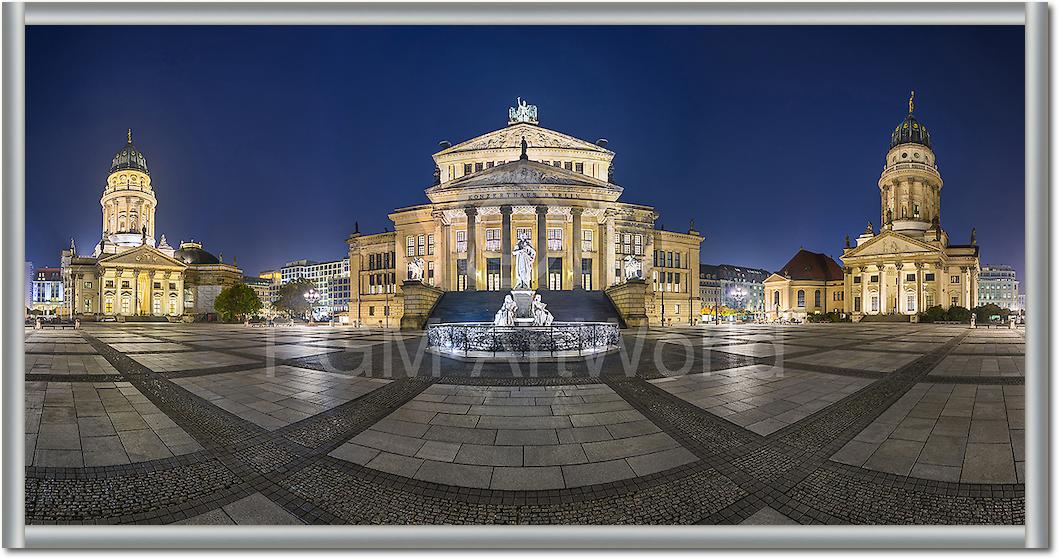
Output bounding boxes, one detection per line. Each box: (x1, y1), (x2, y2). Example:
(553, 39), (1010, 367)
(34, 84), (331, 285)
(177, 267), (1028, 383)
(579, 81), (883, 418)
(99, 130), (158, 248)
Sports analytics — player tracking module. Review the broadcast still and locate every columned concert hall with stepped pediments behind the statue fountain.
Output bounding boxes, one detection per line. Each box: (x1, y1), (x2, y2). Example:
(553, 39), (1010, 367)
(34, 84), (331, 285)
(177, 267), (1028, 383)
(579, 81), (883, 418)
(347, 100), (703, 326)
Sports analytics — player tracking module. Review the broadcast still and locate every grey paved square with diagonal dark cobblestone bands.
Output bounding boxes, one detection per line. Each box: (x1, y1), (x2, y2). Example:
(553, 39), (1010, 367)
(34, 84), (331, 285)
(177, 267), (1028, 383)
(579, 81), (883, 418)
(24, 323), (1025, 525)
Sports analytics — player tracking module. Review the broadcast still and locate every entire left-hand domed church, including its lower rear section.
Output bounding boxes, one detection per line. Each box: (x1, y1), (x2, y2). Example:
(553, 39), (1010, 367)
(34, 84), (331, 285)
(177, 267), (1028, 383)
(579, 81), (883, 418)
(60, 129), (242, 320)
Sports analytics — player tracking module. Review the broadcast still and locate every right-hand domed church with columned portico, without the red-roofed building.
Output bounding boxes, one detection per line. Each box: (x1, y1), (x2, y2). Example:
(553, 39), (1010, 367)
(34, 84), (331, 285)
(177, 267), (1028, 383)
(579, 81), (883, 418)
(836, 92), (981, 321)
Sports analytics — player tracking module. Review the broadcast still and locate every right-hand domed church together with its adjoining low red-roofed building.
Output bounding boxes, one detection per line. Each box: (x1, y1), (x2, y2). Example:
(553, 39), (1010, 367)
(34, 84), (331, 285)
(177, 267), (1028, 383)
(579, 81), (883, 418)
(765, 96), (981, 321)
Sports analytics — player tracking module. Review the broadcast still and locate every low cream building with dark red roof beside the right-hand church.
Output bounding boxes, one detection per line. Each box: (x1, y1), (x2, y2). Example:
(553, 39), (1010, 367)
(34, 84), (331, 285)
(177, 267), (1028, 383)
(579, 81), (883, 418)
(764, 248), (858, 322)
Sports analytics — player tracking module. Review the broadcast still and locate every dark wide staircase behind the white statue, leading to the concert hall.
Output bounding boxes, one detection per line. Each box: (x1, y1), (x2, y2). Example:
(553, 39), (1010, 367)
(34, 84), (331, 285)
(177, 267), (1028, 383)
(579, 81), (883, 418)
(427, 290), (624, 327)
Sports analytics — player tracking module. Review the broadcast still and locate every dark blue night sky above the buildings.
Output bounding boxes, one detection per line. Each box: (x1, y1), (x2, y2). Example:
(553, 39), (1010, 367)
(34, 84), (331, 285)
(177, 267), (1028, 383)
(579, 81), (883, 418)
(25, 26), (1024, 283)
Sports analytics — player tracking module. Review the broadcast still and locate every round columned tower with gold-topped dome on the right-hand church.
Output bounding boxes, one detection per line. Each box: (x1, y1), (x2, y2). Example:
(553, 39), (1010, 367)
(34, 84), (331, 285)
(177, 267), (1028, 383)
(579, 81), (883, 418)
(878, 92), (944, 235)
